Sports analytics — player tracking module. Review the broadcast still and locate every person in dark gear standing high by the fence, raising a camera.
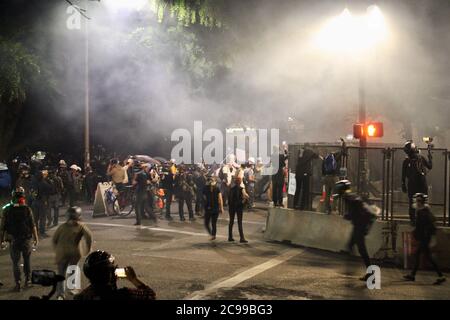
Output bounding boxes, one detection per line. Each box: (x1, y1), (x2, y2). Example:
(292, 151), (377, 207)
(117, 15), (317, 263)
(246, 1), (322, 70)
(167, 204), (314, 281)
(402, 140), (433, 225)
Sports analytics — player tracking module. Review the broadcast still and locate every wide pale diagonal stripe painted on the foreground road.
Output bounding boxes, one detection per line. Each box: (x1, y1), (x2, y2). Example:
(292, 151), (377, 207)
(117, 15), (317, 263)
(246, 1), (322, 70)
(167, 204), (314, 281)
(184, 249), (305, 300)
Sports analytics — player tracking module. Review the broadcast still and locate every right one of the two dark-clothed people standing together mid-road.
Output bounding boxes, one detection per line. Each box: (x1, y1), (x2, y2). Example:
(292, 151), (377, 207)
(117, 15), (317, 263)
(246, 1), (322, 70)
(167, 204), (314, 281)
(228, 177), (248, 243)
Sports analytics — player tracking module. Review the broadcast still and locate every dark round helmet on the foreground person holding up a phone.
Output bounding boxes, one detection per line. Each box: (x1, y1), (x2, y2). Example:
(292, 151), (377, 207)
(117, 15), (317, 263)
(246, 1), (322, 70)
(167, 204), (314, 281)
(83, 250), (116, 284)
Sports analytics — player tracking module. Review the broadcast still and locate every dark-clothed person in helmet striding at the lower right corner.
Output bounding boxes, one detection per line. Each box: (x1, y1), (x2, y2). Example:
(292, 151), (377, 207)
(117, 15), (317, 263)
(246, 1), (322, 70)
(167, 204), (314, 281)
(404, 193), (446, 285)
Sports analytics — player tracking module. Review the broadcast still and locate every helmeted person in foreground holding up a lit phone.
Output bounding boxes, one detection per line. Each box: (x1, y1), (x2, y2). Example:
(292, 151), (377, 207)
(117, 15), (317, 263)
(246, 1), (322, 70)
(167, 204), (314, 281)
(74, 250), (156, 300)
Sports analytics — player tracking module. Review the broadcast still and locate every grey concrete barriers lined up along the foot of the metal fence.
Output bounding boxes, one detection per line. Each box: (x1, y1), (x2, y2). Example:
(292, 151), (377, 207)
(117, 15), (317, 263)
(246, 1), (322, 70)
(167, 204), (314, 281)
(264, 208), (450, 269)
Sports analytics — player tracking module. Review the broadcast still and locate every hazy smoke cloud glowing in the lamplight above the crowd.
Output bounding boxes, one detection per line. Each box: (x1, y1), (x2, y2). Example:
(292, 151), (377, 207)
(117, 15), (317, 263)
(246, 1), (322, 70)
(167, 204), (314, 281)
(44, 0), (450, 155)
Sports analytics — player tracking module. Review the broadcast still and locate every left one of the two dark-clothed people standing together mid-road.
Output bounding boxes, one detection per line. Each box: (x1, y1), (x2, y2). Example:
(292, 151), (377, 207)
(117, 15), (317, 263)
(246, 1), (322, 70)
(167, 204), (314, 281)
(202, 177), (223, 240)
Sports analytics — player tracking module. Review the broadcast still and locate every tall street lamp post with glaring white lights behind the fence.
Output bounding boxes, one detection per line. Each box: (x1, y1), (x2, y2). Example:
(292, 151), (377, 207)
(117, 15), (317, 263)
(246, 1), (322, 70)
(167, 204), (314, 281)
(316, 6), (387, 197)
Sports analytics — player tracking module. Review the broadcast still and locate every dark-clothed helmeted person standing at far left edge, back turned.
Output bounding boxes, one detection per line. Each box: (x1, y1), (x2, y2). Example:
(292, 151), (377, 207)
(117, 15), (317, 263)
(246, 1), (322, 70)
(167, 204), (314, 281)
(0, 187), (39, 291)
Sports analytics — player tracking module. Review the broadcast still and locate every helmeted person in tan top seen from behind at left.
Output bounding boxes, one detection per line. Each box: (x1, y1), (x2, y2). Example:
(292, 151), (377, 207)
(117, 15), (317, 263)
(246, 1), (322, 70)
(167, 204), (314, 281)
(52, 207), (92, 300)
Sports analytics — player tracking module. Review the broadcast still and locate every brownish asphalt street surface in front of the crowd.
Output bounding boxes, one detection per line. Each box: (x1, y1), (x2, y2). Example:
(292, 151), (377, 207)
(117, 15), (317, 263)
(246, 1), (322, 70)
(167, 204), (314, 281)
(0, 202), (450, 300)
